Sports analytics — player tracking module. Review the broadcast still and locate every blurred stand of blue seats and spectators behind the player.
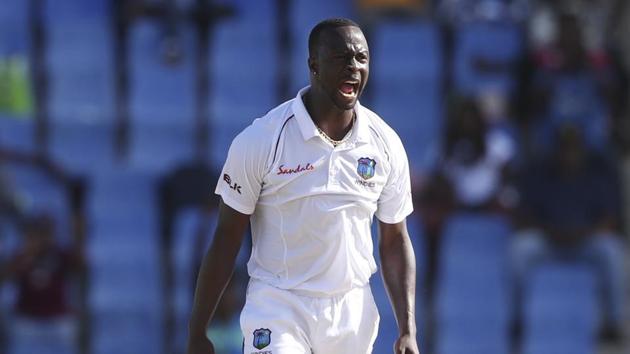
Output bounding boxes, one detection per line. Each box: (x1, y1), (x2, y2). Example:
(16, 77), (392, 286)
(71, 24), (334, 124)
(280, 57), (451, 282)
(0, 0), (630, 354)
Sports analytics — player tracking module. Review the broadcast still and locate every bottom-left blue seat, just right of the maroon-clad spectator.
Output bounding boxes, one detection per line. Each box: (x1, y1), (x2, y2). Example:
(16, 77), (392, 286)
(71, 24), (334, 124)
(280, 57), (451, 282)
(87, 169), (164, 354)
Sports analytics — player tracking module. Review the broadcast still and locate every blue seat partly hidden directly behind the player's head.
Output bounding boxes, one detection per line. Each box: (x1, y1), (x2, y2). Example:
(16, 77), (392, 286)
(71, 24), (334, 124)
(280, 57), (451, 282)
(290, 0), (354, 93)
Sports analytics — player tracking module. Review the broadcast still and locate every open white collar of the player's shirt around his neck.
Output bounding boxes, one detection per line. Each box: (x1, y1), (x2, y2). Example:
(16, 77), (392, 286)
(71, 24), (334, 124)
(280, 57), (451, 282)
(293, 86), (369, 143)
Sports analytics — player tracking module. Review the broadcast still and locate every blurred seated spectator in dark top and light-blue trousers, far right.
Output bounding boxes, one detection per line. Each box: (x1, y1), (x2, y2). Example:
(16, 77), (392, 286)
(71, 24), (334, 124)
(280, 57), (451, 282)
(511, 127), (625, 338)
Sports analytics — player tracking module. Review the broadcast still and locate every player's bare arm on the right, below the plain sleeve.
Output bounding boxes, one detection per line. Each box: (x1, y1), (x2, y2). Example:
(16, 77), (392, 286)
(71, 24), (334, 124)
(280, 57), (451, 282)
(379, 220), (420, 354)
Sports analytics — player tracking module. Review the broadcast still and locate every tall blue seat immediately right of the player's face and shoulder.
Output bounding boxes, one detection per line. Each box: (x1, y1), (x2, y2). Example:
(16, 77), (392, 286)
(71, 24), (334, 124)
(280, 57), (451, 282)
(376, 22), (443, 171)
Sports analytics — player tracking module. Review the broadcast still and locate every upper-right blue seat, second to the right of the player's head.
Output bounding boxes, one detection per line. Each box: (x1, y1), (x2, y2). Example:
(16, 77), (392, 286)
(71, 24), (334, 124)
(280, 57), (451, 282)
(453, 22), (524, 94)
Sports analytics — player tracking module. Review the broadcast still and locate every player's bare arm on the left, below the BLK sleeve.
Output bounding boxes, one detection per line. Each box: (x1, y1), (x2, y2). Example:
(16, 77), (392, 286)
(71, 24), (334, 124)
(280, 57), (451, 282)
(187, 201), (249, 354)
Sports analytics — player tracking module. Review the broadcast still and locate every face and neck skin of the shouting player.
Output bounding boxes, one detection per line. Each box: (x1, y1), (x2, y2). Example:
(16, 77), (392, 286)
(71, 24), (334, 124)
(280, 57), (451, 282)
(304, 26), (370, 140)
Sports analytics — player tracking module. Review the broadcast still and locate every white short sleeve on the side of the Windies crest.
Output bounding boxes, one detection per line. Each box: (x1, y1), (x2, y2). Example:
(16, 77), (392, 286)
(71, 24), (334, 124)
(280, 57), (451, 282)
(376, 137), (413, 224)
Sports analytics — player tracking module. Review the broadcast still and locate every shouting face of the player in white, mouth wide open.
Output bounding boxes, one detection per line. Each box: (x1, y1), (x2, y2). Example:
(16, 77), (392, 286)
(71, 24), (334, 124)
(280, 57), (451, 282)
(309, 26), (370, 110)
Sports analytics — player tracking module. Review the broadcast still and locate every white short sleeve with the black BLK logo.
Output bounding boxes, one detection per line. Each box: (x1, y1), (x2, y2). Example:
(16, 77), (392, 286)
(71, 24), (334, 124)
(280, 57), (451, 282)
(215, 126), (267, 215)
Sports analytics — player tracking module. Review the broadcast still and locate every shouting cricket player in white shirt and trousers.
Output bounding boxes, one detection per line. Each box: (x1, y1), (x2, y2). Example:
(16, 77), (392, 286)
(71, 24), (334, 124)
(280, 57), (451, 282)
(187, 19), (419, 354)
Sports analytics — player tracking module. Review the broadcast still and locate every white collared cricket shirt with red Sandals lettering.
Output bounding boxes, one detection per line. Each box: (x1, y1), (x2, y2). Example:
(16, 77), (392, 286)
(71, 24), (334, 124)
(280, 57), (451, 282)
(215, 87), (413, 296)
